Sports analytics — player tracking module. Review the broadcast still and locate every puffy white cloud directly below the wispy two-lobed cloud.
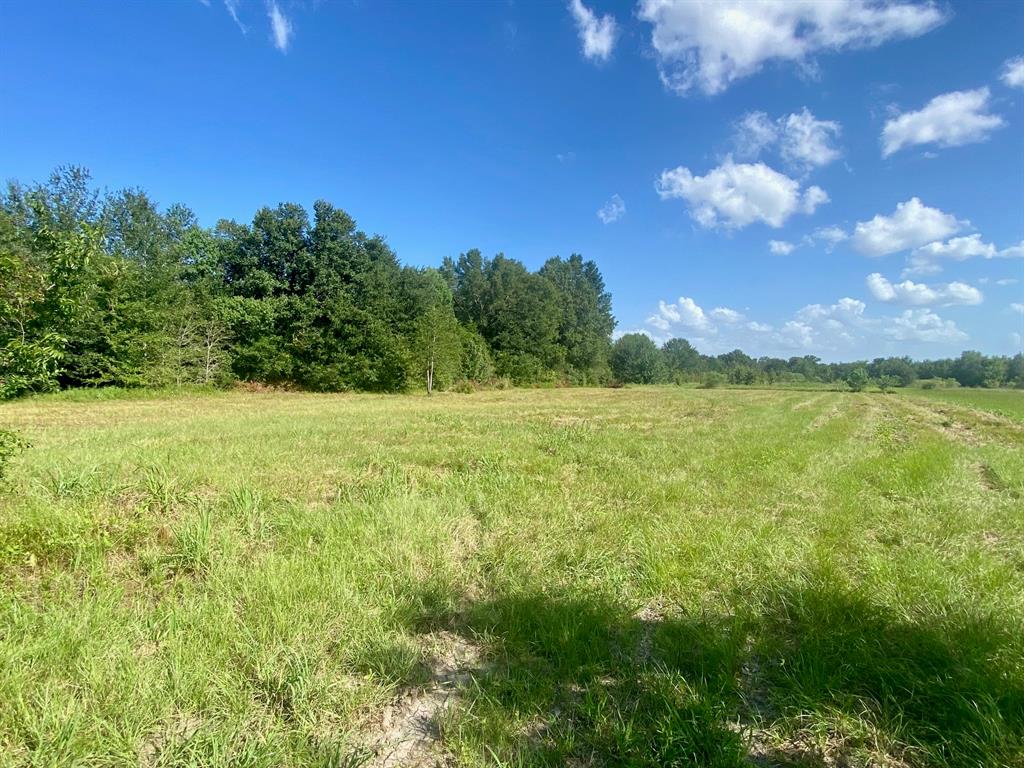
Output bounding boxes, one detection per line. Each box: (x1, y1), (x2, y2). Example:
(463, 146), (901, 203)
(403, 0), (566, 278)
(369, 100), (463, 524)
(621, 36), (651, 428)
(655, 157), (828, 229)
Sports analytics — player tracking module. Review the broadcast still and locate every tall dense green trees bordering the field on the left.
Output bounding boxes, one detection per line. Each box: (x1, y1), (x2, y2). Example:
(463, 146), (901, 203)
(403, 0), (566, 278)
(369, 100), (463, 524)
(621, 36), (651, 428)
(0, 168), (614, 397)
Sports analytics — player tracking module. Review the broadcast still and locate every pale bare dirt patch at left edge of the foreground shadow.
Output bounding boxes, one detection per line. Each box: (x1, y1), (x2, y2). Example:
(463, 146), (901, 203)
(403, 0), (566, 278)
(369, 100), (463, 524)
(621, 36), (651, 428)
(364, 631), (480, 768)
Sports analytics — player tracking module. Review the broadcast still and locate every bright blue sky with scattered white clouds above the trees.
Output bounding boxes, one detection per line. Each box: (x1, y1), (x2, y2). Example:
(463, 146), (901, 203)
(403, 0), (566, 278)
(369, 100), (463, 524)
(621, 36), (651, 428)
(0, 0), (1024, 359)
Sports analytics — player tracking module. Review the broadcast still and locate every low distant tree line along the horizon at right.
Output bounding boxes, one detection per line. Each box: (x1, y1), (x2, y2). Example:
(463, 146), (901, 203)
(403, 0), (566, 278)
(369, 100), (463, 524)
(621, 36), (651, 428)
(611, 334), (1024, 389)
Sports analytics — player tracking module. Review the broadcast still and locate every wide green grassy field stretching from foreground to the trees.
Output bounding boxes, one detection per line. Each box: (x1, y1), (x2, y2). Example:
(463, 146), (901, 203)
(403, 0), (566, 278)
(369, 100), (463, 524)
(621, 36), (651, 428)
(0, 388), (1024, 768)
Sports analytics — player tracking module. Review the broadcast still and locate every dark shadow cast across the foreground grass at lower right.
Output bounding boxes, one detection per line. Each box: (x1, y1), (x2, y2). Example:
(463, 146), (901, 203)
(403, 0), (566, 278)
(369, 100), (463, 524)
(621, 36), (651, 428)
(403, 586), (1024, 766)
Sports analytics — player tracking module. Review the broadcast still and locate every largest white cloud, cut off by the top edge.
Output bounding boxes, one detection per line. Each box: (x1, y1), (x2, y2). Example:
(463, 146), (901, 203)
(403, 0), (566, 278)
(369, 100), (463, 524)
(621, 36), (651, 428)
(638, 0), (946, 94)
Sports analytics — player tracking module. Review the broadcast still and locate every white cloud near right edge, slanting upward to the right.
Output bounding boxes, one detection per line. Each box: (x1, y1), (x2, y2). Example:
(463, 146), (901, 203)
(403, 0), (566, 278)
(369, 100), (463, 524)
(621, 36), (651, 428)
(882, 88), (1006, 158)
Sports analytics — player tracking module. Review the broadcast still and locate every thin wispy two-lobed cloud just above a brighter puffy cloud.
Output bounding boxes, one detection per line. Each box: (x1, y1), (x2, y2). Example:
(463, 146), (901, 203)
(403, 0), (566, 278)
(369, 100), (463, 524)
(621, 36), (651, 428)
(735, 106), (841, 170)
